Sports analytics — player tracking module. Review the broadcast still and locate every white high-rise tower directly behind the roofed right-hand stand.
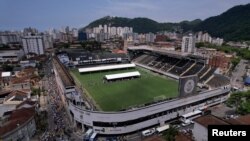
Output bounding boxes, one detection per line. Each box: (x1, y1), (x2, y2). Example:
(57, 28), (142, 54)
(181, 34), (195, 53)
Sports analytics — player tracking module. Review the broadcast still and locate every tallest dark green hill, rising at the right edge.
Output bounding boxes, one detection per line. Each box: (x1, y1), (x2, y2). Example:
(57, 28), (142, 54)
(194, 4), (250, 41)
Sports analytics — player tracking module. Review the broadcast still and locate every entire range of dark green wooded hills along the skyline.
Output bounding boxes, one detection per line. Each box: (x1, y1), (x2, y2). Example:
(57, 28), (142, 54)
(83, 4), (250, 41)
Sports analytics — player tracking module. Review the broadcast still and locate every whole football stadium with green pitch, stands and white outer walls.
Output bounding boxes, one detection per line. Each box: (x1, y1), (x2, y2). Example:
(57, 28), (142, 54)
(53, 47), (230, 135)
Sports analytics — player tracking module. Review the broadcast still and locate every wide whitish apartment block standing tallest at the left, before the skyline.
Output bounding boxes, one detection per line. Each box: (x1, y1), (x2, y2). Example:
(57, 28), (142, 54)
(22, 36), (45, 55)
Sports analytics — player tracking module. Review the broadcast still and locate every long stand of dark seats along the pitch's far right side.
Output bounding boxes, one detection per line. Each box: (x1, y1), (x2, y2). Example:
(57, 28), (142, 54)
(134, 54), (216, 80)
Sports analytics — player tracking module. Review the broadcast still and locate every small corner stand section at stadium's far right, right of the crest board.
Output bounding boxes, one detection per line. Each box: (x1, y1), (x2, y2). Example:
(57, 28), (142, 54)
(206, 74), (230, 88)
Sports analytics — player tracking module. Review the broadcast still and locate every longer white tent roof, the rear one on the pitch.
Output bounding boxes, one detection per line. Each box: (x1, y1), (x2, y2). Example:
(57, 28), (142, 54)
(78, 64), (135, 73)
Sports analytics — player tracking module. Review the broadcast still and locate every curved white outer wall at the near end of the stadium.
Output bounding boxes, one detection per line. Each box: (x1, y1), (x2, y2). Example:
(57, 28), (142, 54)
(69, 86), (230, 135)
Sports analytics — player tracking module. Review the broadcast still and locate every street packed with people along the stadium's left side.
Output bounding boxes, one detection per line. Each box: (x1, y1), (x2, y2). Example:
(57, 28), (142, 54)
(39, 61), (81, 141)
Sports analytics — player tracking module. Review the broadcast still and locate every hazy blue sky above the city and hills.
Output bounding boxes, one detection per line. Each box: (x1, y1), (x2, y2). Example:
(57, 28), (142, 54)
(0, 0), (250, 30)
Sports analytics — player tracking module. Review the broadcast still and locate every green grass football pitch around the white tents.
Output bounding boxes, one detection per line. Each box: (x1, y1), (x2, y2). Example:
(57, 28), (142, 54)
(71, 68), (178, 111)
